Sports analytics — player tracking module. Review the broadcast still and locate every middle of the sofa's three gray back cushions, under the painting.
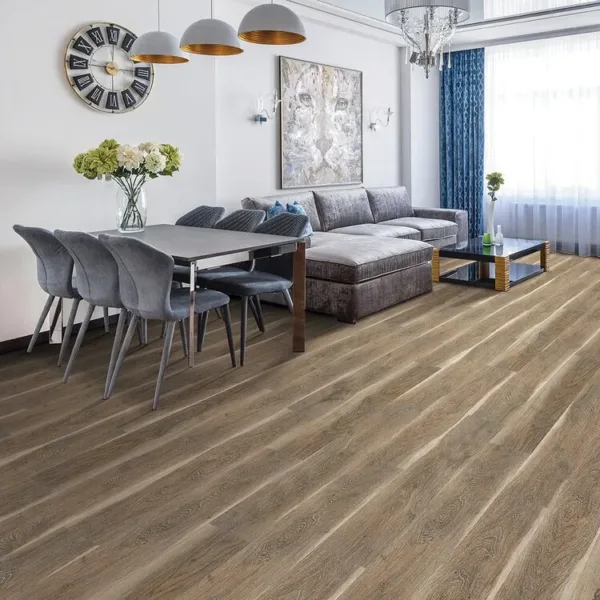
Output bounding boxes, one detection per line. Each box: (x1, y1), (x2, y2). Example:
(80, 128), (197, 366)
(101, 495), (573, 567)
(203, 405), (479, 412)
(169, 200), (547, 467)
(315, 188), (373, 231)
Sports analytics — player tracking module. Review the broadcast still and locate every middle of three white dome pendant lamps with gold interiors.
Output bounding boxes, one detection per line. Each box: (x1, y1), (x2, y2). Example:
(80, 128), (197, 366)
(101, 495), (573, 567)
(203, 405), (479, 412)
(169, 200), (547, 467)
(179, 0), (243, 56)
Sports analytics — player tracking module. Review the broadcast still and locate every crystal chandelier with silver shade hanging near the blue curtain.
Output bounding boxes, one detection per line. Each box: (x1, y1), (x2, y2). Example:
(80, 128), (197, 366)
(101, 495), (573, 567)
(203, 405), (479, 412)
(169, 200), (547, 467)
(385, 0), (471, 78)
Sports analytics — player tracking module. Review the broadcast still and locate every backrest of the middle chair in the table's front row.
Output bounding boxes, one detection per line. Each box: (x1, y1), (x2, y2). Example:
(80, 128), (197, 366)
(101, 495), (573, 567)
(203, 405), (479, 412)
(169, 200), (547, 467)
(54, 229), (122, 308)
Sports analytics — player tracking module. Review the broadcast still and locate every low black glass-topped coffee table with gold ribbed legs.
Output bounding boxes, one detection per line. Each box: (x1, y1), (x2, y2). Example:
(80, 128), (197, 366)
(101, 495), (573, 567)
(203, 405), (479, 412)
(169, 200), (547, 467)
(432, 237), (550, 292)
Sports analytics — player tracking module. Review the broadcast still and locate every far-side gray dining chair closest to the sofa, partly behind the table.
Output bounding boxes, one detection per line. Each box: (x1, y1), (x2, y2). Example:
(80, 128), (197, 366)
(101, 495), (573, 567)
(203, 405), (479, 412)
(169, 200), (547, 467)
(197, 213), (308, 366)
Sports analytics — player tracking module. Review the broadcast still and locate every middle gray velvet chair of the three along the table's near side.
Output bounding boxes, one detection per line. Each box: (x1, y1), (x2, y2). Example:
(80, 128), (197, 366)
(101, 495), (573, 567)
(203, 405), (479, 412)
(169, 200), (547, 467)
(54, 229), (139, 397)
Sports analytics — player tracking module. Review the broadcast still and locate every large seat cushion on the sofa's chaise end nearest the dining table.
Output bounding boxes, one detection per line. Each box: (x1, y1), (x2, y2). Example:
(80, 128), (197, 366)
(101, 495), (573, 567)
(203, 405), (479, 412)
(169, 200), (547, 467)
(306, 234), (433, 284)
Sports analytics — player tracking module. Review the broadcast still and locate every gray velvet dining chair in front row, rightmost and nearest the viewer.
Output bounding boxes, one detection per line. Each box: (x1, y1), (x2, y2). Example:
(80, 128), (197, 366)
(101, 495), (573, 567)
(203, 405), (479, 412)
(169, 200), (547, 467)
(100, 234), (236, 409)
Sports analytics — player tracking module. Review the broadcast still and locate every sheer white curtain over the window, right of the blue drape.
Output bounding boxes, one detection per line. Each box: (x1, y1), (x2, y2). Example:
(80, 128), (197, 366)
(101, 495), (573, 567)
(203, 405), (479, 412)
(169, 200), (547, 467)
(485, 33), (600, 256)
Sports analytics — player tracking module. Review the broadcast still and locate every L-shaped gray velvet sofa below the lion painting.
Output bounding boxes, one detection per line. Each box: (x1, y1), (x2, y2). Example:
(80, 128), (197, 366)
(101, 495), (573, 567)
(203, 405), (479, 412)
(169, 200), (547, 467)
(242, 187), (469, 323)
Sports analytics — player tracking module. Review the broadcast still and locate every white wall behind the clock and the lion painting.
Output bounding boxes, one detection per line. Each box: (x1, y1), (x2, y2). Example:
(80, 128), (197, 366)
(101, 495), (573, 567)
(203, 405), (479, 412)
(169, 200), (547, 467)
(0, 0), (401, 341)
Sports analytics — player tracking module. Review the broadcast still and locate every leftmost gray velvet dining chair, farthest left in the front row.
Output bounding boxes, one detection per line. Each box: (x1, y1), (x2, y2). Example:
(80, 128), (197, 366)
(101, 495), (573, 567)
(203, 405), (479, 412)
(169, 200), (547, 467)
(13, 225), (81, 367)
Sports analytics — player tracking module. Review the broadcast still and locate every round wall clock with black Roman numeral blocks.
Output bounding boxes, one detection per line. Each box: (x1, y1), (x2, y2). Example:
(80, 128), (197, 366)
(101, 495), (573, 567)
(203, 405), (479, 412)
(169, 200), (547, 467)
(65, 23), (154, 113)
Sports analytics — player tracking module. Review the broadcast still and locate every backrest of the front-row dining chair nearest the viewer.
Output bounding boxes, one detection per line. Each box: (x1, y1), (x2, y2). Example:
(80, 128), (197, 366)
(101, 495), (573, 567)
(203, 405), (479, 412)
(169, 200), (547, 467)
(100, 234), (174, 320)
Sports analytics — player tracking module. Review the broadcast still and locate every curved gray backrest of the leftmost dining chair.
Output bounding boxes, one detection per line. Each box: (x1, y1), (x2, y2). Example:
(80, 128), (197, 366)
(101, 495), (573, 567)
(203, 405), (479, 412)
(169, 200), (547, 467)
(13, 225), (75, 298)
